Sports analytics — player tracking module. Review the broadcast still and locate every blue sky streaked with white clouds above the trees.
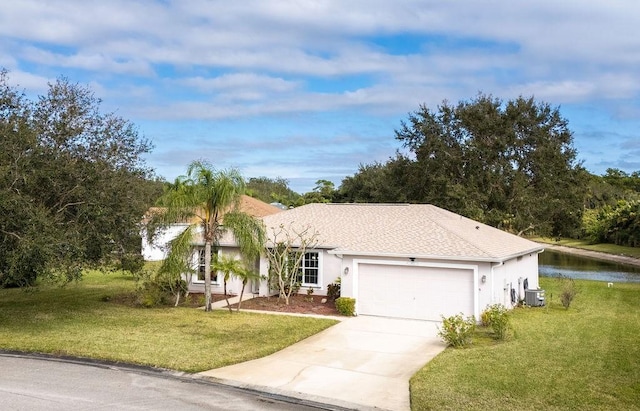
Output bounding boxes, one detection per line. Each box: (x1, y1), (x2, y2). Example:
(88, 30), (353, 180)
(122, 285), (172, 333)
(0, 0), (640, 193)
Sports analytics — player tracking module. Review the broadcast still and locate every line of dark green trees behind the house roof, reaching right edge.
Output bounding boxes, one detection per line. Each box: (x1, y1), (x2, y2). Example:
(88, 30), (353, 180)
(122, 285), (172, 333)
(249, 94), (640, 246)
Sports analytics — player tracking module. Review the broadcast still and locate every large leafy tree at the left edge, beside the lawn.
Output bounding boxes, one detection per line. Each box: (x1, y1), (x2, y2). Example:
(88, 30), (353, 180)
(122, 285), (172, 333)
(0, 70), (159, 286)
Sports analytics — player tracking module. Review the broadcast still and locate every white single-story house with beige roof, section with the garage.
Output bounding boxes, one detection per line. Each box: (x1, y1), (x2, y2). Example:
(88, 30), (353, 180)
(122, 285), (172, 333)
(259, 204), (543, 321)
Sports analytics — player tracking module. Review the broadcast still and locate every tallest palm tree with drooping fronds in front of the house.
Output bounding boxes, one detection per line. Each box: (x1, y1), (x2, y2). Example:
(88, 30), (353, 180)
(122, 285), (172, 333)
(152, 161), (265, 311)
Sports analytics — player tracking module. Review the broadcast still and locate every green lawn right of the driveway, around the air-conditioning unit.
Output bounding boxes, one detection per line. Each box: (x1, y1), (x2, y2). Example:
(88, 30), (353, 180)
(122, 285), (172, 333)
(411, 278), (640, 410)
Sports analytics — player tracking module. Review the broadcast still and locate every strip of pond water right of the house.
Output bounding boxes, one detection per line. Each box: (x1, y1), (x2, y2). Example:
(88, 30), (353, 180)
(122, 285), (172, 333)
(538, 250), (640, 283)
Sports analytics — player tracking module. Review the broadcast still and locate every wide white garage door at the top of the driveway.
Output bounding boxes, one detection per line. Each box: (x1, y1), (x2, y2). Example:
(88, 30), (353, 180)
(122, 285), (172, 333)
(357, 263), (474, 321)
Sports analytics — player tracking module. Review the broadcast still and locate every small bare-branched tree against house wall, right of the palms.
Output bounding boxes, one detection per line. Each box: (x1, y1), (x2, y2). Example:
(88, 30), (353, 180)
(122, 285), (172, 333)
(266, 224), (319, 305)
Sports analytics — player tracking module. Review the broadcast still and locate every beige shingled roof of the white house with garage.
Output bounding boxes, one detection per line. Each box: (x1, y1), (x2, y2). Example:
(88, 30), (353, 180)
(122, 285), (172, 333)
(263, 204), (543, 262)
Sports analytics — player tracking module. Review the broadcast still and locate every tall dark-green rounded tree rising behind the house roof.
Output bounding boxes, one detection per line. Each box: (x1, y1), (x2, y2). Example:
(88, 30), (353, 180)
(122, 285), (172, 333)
(340, 94), (588, 235)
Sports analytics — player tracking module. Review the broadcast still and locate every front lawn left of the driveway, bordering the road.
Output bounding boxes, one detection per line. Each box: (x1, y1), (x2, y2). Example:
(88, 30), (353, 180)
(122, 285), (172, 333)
(0, 272), (335, 372)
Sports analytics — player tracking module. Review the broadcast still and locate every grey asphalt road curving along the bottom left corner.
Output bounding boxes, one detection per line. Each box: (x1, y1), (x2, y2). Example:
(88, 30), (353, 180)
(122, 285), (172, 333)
(0, 353), (336, 411)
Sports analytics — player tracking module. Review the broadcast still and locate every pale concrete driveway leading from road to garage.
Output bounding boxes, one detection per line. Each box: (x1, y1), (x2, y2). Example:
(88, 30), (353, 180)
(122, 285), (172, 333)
(202, 316), (445, 410)
